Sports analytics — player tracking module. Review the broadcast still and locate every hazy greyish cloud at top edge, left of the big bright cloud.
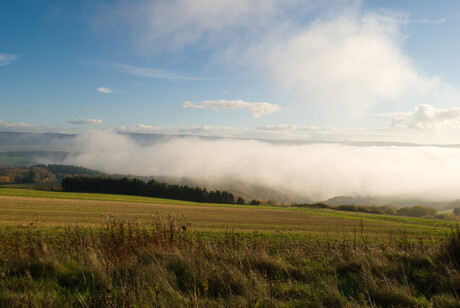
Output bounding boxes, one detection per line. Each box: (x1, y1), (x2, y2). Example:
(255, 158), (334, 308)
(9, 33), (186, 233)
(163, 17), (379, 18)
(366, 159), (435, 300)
(106, 0), (294, 50)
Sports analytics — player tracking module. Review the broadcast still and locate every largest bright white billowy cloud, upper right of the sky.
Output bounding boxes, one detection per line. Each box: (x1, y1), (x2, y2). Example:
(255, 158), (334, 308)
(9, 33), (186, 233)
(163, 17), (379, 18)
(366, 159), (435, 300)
(246, 12), (440, 113)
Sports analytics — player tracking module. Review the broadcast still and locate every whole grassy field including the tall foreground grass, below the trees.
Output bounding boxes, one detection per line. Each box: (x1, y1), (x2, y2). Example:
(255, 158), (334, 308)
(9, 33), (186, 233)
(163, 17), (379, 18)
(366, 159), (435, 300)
(0, 188), (460, 307)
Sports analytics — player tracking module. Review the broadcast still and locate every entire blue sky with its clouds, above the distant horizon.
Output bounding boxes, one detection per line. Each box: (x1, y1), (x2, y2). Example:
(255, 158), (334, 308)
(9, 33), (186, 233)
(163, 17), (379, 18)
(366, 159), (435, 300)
(0, 0), (460, 143)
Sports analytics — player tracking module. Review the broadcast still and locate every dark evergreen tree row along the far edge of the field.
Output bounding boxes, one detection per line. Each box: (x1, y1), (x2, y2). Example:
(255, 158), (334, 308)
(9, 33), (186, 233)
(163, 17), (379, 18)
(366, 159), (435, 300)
(61, 176), (245, 204)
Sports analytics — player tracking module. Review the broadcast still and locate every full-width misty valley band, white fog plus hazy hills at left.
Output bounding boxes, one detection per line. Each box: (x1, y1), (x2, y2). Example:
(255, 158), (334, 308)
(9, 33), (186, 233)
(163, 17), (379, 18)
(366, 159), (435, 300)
(0, 130), (460, 207)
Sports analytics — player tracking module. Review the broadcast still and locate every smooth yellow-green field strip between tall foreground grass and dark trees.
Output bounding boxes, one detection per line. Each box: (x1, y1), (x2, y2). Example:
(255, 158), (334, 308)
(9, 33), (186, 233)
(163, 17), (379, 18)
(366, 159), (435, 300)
(0, 188), (455, 240)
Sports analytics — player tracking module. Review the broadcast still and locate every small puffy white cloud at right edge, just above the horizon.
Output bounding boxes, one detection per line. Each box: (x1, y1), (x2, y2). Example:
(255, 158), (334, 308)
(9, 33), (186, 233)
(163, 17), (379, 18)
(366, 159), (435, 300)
(376, 104), (460, 132)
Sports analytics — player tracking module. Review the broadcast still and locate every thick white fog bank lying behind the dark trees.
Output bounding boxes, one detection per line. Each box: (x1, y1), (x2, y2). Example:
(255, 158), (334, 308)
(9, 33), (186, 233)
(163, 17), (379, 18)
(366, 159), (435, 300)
(64, 131), (460, 201)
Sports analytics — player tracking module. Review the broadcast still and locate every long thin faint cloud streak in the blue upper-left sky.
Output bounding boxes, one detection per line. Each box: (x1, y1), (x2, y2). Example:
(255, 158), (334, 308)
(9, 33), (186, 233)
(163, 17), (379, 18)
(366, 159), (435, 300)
(104, 63), (207, 80)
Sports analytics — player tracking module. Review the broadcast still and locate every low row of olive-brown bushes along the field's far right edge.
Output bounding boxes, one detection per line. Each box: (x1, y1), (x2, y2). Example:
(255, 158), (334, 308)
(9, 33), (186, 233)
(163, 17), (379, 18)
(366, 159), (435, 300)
(292, 203), (437, 217)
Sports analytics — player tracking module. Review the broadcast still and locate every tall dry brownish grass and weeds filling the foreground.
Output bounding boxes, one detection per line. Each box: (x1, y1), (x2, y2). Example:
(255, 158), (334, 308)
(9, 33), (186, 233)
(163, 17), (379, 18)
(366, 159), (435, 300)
(0, 215), (460, 307)
